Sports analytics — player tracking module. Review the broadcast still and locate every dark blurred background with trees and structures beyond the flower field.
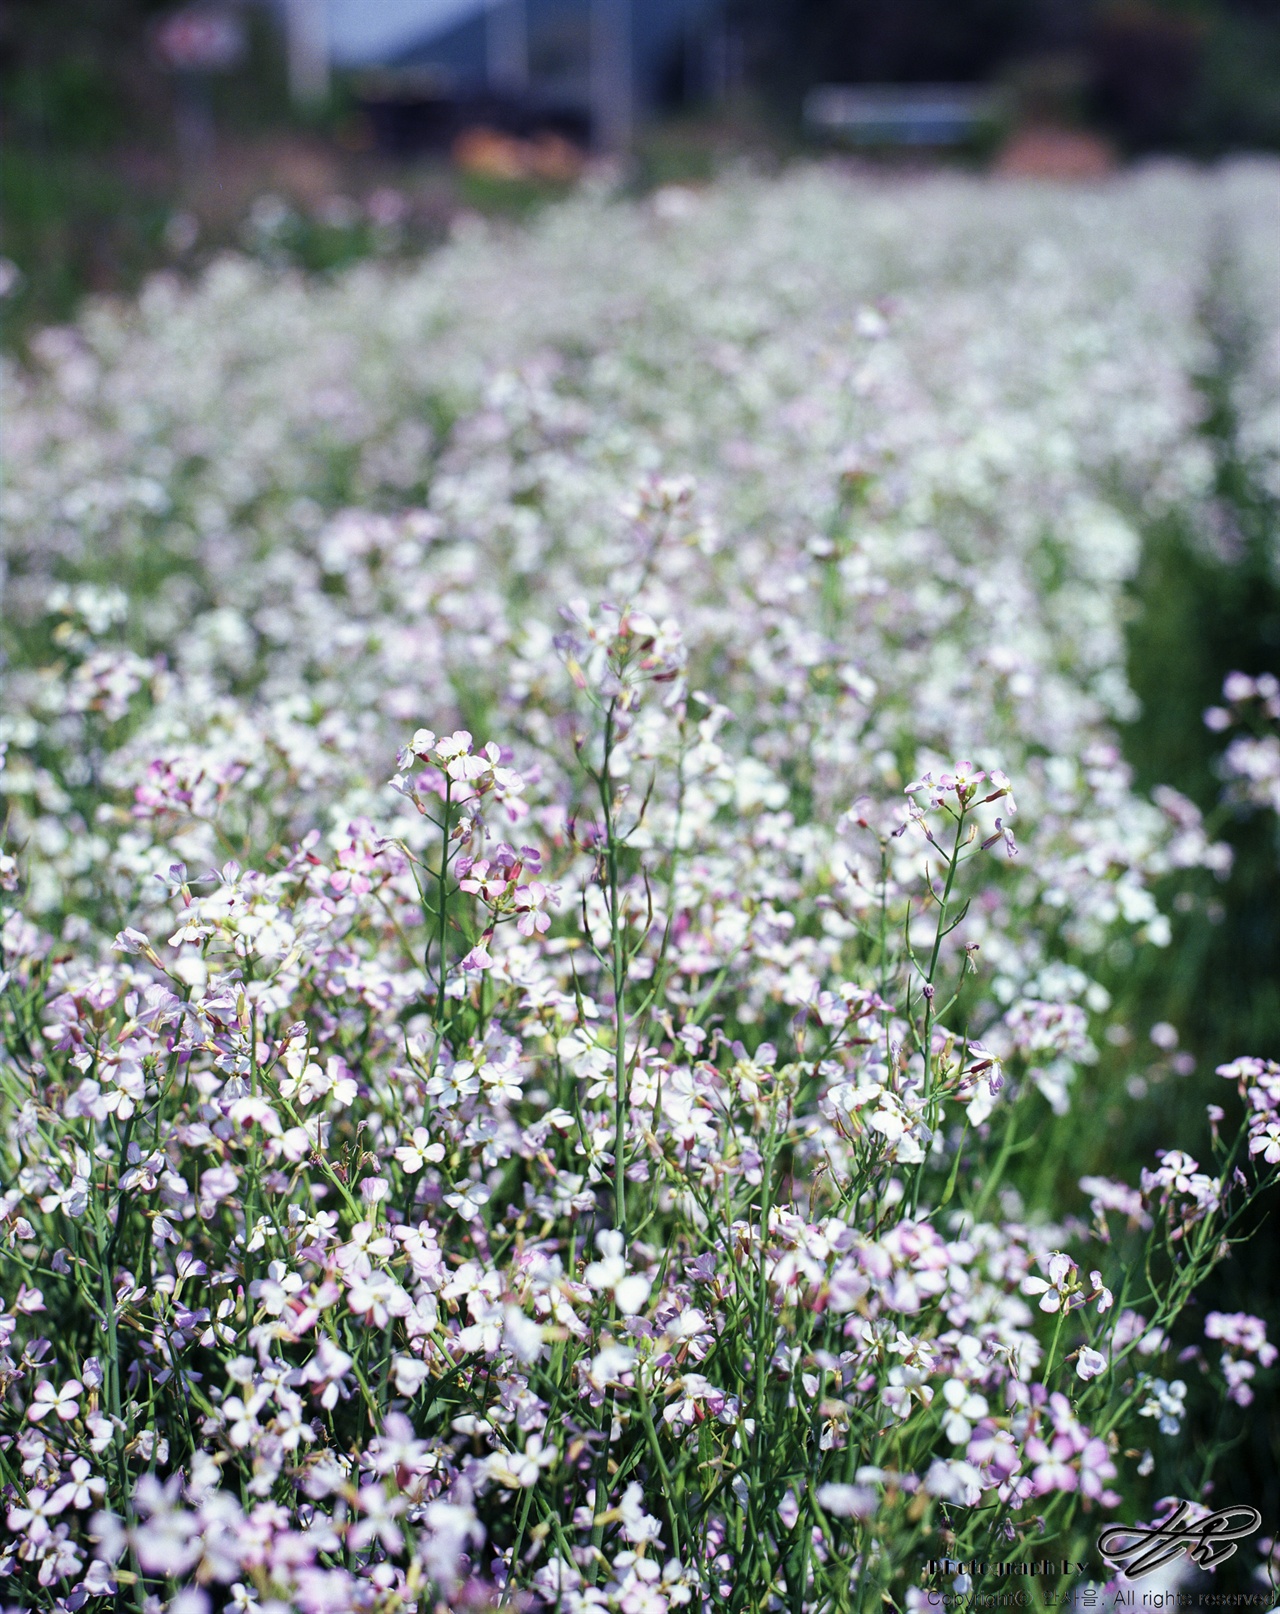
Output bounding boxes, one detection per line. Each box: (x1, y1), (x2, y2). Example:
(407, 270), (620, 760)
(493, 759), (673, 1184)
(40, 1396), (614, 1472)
(0, 0), (1280, 342)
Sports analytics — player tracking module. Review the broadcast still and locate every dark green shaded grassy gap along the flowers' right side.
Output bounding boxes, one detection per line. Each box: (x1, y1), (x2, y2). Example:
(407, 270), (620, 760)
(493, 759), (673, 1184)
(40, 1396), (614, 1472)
(1102, 255), (1280, 1549)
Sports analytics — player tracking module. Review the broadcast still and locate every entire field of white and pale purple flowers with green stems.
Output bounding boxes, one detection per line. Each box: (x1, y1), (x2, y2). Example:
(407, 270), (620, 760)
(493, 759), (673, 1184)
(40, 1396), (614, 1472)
(0, 163), (1280, 1614)
